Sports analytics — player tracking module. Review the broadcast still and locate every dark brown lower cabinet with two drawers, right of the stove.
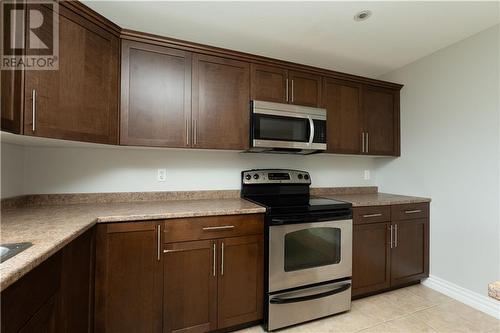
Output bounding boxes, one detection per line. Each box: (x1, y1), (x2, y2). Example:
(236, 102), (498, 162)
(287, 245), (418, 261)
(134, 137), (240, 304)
(352, 203), (429, 297)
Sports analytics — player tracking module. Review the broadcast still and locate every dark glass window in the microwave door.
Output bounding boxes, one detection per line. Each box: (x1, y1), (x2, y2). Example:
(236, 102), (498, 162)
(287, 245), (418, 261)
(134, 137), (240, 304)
(253, 114), (310, 142)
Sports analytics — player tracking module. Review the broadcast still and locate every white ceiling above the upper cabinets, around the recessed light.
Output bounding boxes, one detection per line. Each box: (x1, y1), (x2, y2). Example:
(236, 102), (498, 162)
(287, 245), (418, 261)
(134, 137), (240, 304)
(84, 1), (500, 77)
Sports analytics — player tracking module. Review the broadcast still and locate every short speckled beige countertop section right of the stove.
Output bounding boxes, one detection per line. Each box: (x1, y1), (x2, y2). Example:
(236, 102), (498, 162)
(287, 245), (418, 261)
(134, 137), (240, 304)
(322, 192), (431, 207)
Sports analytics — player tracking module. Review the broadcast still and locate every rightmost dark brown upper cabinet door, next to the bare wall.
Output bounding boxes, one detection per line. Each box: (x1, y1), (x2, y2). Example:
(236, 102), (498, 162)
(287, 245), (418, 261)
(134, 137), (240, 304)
(363, 86), (400, 156)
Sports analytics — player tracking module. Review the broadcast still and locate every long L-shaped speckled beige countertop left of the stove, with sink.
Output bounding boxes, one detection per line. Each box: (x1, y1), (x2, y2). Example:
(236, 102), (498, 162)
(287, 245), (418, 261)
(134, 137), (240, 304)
(0, 199), (265, 291)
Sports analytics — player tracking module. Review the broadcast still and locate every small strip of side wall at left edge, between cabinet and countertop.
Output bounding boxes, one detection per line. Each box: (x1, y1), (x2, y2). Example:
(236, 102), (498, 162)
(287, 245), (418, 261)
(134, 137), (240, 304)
(0, 142), (24, 198)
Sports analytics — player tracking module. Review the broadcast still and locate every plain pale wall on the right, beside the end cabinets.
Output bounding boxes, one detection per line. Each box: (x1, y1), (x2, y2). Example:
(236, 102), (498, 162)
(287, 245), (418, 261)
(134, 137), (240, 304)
(377, 25), (500, 295)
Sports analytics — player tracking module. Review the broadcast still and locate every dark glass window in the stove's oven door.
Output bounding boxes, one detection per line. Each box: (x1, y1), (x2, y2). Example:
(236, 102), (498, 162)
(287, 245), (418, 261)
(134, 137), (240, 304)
(284, 227), (341, 272)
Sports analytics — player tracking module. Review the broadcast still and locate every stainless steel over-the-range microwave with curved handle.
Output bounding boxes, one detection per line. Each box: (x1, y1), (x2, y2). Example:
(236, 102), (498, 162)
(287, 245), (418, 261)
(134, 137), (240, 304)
(249, 101), (326, 154)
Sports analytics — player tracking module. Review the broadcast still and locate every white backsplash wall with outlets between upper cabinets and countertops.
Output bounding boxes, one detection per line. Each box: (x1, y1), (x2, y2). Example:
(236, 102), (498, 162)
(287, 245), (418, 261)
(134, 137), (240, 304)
(2, 142), (375, 197)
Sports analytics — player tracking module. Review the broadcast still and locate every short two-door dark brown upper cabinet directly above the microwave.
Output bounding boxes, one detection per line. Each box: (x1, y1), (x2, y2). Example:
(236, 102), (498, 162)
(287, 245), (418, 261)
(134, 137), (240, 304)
(251, 64), (321, 107)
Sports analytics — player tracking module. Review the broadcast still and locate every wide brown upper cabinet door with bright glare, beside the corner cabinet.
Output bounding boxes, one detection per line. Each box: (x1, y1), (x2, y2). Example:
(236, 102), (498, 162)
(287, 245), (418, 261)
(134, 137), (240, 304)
(120, 40), (191, 147)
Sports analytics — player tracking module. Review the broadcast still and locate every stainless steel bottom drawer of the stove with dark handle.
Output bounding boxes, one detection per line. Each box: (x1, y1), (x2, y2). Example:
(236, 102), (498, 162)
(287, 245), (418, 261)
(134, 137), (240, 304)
(267, 280), (351, 331)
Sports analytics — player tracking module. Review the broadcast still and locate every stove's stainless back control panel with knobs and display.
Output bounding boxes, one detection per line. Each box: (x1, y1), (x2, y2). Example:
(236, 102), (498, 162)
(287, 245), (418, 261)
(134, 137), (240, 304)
(241, 169), (311, 185)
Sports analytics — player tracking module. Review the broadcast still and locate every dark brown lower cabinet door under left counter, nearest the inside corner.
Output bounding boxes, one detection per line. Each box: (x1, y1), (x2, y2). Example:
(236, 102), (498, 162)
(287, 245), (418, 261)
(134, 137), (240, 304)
(57, 228), (95, 333)
